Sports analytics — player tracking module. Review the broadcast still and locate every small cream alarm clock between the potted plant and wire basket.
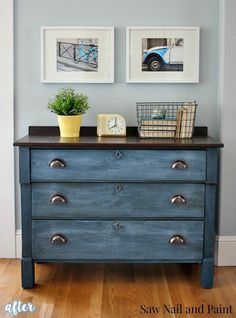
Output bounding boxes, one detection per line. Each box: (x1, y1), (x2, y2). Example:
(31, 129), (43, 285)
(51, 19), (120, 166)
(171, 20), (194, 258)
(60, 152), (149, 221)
(97, 114), (126, 137)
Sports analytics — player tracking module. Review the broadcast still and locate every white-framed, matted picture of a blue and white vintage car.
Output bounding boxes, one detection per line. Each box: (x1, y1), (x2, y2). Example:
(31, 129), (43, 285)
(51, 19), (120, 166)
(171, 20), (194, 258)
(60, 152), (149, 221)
(126, 26), (200, 83)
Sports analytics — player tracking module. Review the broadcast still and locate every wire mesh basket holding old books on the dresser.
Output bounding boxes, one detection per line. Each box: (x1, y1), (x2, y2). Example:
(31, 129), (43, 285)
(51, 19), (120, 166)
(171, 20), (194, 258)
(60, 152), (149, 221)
(136, 101), (197, 138)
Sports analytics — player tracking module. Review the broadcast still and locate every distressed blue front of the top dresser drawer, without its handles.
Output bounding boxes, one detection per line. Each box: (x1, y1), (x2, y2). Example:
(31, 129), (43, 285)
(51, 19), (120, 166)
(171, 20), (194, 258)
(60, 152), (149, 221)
(31, 149), (206, 182)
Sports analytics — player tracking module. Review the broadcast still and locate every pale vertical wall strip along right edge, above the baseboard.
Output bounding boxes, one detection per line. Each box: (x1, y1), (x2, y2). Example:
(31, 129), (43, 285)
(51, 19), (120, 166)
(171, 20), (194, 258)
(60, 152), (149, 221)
(219, 0), (236, 235)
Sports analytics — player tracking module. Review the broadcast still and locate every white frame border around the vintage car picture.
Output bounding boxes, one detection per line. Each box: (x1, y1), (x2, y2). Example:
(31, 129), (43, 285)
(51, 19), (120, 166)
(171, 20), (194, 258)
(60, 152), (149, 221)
(126, 26), (200, 83)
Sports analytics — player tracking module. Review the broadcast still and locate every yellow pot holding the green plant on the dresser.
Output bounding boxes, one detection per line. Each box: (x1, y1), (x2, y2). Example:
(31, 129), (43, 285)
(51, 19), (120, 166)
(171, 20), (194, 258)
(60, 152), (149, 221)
(57, 115), (82, 137)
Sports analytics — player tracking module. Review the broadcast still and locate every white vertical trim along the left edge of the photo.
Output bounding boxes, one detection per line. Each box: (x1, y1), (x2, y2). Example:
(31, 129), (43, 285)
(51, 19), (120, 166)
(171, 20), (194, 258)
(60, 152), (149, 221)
(0, 0), (15, 258)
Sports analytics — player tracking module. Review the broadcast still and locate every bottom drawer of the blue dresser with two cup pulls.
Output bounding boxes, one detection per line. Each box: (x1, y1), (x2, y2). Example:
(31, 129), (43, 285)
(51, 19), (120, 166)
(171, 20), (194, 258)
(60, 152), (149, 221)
(32, 220), (203, 261)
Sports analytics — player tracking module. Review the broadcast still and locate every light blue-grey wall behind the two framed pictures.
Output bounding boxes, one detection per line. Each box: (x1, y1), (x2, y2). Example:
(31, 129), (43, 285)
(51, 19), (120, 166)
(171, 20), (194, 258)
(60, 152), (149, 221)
(15, 0), (219, 227)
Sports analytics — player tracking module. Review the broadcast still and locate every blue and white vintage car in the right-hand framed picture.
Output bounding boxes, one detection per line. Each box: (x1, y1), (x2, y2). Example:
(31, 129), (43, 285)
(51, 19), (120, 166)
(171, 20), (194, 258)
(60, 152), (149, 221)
(143, 39), (184, 71)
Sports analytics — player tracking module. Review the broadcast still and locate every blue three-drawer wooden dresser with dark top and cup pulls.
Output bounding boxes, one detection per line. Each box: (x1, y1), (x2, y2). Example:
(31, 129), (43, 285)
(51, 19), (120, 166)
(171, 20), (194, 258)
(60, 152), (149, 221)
(15, 127), (223, 288)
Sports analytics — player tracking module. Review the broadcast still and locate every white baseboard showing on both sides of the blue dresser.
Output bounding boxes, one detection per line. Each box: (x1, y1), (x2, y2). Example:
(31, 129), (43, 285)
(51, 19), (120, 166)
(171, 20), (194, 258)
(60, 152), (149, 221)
(16, 230), (236, 266)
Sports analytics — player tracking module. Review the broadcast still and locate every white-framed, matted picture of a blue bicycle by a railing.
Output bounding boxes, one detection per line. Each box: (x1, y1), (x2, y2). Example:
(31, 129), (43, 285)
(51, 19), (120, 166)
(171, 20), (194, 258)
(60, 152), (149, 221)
(41, 26), (114, 83)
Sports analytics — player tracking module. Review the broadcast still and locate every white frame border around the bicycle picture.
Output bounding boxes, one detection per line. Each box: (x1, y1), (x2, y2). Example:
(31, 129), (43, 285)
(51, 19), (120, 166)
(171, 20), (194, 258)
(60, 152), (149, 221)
(40, 26), (114, 83)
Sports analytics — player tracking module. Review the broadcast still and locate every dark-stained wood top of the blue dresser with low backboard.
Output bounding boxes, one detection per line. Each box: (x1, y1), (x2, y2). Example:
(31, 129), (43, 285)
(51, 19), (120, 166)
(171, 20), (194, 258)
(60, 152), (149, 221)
(14, 126), (223, 149)
